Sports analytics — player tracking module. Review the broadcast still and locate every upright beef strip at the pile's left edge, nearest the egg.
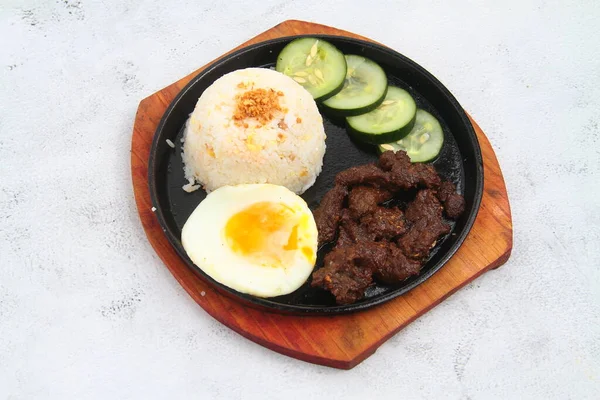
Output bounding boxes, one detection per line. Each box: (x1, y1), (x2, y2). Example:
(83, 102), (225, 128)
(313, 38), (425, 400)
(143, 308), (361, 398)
(313, 185), (348, 245)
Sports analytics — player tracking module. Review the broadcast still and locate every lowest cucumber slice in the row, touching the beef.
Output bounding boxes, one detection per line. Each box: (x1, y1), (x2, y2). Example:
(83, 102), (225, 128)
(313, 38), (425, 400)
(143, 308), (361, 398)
(379, 109), (444, 162)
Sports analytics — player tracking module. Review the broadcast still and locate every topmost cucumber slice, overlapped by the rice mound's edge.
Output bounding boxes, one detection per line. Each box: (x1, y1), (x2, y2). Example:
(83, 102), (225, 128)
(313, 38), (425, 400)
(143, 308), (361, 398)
(275, 38), (346, 100)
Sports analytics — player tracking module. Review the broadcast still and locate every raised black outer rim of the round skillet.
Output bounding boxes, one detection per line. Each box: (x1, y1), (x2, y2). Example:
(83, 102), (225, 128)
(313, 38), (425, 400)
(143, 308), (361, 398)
(148, 34), (484, 315)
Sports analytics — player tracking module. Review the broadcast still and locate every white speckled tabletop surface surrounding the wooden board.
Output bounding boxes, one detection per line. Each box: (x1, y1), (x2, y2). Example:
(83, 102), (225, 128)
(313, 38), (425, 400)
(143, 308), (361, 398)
(0, 0), (600, 399)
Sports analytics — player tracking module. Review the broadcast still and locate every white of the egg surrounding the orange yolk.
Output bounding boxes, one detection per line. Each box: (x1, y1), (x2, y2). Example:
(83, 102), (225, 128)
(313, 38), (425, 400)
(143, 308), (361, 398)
(181, 184), (318, 297)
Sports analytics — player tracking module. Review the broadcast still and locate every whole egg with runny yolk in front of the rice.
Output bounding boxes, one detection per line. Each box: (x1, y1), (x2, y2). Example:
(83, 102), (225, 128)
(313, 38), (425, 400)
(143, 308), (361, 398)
(181, 184), (318, 297)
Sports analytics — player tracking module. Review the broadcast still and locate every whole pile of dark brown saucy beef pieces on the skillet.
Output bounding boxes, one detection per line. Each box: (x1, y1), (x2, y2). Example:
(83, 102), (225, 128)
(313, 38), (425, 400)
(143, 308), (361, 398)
(311, 151), (465, 304)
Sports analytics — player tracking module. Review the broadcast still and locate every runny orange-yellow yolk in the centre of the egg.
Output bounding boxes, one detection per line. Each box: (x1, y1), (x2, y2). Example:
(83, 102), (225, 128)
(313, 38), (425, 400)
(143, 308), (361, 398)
(224, 201), (314, 267)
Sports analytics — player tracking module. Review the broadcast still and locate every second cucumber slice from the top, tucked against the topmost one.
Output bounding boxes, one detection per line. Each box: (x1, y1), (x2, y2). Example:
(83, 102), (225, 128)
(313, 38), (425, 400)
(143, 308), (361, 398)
(322, 54), (387, 116)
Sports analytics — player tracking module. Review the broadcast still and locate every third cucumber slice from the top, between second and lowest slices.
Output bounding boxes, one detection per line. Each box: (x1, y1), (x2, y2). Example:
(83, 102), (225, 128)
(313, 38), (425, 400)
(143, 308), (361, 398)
(346, 86), (417, 144)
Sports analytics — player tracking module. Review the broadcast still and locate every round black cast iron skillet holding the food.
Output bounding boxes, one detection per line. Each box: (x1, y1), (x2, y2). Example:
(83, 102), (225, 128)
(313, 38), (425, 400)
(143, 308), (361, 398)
(148, 35), (483, 314)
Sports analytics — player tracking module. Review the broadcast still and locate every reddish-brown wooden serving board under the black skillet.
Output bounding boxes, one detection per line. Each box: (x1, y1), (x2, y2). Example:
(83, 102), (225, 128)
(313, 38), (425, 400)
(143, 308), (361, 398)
(131, 20), (512, 369)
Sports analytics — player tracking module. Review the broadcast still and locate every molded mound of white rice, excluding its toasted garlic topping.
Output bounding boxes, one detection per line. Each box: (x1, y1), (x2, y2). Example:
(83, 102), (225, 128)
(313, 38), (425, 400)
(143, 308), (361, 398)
(183, 68), (325, 194)
